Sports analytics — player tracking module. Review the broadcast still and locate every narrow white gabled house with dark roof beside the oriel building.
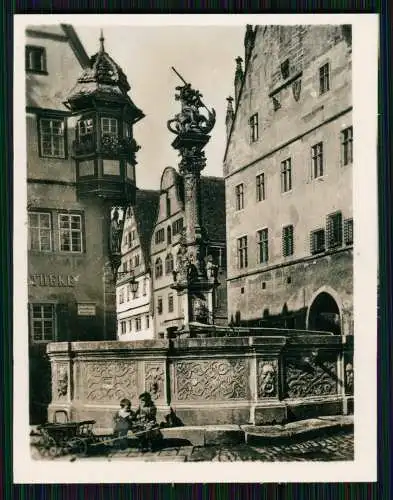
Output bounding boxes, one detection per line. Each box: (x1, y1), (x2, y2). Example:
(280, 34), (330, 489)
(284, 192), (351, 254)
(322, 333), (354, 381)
(116, 190), (159, 341)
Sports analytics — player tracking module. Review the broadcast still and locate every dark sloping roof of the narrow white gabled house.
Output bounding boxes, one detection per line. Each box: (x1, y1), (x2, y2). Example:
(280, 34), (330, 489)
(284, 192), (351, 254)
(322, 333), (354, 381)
(133, 189), (160, 268)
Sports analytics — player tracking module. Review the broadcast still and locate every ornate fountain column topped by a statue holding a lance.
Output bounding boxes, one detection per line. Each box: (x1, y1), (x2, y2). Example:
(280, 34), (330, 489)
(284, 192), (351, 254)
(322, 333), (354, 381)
(168, 72), (219, 331)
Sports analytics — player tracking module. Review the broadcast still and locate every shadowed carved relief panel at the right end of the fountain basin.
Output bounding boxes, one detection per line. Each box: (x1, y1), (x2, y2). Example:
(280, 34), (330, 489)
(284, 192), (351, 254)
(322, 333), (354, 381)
(285, 357), (337, 398)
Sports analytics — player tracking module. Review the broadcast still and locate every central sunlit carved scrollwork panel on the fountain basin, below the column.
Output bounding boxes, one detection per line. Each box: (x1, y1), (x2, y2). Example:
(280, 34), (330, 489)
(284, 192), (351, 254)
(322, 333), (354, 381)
(175, 359), (249, 401)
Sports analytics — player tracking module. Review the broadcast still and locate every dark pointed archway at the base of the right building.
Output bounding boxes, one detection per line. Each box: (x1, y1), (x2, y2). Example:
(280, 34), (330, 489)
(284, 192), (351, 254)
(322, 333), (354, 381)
(307, 291), (341, 335)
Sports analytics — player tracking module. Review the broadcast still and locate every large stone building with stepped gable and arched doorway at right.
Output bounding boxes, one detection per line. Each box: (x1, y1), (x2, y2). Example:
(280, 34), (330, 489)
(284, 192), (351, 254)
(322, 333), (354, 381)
(224, 25), (353, 334)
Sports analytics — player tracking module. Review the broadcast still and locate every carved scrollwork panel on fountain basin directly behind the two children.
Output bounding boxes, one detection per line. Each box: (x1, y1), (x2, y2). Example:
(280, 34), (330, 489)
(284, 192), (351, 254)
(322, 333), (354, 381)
(78, 360), (138, 403)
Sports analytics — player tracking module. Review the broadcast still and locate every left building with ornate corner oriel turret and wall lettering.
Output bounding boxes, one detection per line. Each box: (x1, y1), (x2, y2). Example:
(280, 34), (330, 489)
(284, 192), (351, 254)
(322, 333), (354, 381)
(25, 25), (143, 423)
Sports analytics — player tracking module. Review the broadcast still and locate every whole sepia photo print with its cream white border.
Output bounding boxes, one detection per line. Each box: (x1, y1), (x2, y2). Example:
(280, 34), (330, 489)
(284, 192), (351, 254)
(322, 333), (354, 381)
(14, 15), (378, 483)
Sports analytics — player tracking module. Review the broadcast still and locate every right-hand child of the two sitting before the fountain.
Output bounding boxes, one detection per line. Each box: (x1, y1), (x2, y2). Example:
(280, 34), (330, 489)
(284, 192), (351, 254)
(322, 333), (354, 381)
(133, 392), (162, 451)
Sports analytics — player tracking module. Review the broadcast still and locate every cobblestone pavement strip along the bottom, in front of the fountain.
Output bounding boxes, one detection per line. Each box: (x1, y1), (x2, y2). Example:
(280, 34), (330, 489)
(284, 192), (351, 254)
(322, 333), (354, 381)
(32, 432), (354, 462)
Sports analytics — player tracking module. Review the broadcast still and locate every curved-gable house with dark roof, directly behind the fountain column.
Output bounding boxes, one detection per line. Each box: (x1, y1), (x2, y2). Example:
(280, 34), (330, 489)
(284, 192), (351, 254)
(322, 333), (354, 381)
(150, 167), (227, 337)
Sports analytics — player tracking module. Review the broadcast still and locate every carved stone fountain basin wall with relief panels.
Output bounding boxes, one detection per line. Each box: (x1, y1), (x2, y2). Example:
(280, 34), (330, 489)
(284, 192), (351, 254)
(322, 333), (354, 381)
(48, 334), (353, 429)
